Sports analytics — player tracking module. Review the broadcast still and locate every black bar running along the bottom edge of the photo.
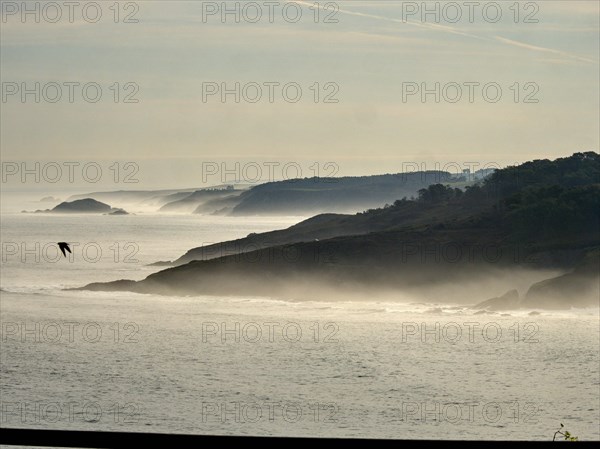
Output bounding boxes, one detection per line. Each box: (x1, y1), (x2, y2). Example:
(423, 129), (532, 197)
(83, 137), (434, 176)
(0, 428), (568, 449)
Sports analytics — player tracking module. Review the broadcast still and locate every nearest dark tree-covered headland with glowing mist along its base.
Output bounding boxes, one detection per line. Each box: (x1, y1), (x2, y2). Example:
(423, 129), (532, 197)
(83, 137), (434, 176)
(85, 152), (600, 308)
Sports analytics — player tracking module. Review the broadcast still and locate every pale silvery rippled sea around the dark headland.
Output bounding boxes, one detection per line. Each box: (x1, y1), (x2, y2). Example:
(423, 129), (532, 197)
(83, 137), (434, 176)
(0, 213), (600, 440)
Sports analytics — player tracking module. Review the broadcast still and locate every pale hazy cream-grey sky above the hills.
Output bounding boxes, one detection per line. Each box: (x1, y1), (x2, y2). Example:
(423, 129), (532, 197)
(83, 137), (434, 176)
(0, 1), (600, 188)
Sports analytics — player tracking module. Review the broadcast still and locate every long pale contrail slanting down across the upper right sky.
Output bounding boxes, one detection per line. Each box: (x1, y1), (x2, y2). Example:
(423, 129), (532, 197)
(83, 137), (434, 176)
(296, 0), (598, 64)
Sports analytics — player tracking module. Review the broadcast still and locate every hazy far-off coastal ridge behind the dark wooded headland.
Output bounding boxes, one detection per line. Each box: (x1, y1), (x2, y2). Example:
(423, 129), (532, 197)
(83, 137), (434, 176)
(70, 171), (472, 216)
